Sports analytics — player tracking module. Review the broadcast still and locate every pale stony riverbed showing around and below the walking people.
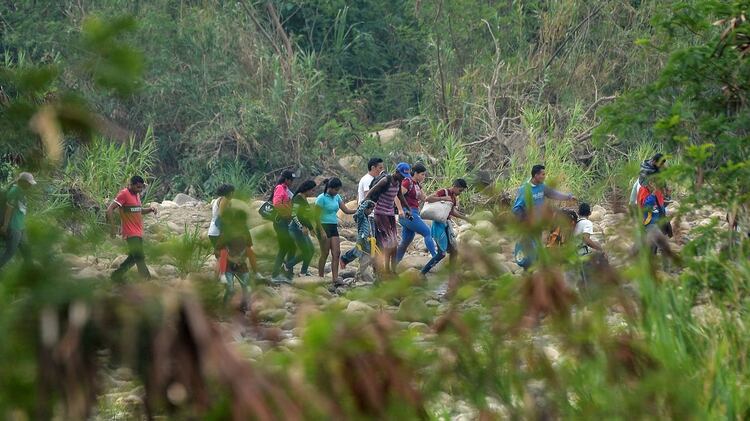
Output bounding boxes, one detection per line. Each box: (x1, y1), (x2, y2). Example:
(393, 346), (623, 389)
(69, 195), (726, 419)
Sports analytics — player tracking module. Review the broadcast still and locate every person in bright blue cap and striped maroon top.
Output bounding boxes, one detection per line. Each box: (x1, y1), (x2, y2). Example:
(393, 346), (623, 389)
(365, 162), (411, 275)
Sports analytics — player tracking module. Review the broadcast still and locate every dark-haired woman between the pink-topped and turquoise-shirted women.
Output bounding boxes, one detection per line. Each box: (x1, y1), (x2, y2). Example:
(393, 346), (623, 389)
(286, 180), (321, 276)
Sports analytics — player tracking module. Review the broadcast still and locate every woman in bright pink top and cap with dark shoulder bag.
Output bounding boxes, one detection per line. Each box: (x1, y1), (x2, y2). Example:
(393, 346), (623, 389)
(271, 170), (296, 283)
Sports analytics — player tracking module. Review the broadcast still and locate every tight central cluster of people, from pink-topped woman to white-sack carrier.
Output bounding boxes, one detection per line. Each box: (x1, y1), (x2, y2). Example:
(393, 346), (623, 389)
(262, 158), (468, 283)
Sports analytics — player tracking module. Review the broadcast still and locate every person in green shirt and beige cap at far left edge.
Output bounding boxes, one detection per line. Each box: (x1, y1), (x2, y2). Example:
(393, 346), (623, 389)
(0, 172), (36, 269)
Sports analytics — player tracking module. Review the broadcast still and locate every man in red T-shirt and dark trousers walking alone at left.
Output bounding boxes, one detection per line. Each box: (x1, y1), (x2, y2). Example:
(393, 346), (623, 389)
(107, 175), (156, 282)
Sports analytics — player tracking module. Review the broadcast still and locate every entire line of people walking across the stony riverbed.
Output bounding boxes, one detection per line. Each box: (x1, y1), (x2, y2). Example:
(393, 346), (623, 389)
(0, 154), (684, 302)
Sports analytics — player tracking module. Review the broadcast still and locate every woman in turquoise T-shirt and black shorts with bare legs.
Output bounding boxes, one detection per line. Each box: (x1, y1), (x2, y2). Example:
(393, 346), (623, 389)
(315, 177), (355, 284)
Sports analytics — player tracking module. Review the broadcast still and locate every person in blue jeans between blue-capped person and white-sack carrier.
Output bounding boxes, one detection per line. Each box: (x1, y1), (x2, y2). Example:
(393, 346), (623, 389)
(396, 164), (437, 263)
